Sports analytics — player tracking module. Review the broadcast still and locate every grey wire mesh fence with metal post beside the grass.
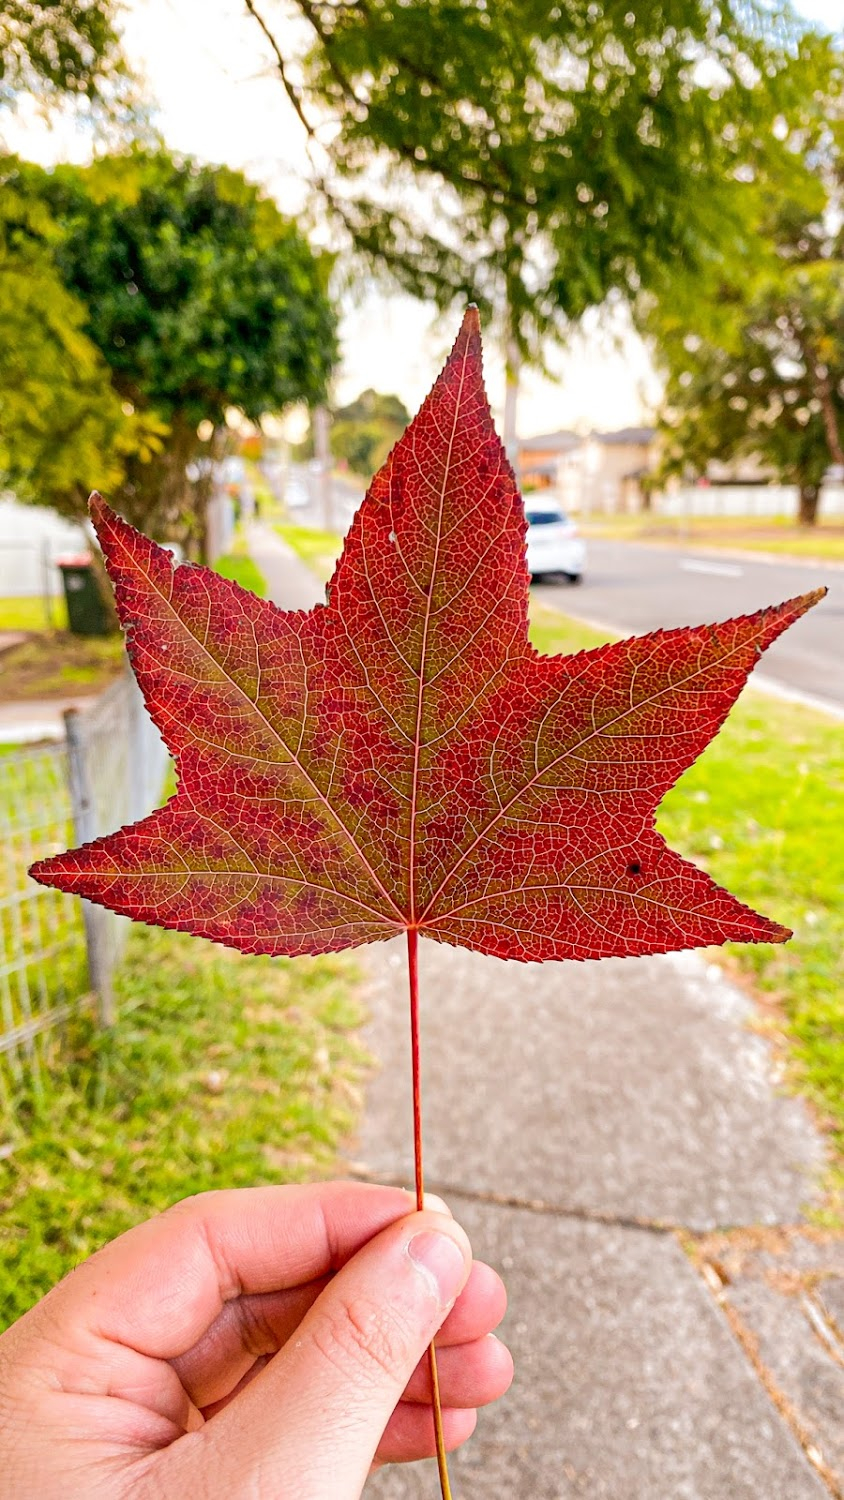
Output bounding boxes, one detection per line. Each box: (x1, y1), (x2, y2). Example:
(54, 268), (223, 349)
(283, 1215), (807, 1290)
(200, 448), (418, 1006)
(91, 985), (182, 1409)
(0, 675), (169, 1095)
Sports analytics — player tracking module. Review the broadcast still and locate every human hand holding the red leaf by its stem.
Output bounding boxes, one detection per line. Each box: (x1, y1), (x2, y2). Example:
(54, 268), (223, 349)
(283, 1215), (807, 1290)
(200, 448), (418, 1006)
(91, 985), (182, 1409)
(0, 1182), (513, 1500)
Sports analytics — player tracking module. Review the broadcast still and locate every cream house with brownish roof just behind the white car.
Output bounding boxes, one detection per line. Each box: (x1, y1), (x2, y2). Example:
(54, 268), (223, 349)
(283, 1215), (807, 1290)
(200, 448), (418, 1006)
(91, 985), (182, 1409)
(519, 428), (657, 513)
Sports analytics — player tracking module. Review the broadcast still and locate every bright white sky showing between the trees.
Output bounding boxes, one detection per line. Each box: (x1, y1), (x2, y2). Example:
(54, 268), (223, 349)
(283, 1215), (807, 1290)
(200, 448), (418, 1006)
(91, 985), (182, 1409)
(4, 0), (844, 437)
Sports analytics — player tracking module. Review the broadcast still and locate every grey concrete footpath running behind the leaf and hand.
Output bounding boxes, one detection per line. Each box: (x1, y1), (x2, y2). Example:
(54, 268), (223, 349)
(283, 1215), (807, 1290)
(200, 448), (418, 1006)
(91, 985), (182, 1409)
(252, 528), (844, 1500)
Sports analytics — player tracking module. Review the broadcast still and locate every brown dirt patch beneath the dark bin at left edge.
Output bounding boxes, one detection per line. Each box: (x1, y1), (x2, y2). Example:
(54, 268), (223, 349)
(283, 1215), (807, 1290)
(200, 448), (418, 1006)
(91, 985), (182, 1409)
(0, 630), (126, 704)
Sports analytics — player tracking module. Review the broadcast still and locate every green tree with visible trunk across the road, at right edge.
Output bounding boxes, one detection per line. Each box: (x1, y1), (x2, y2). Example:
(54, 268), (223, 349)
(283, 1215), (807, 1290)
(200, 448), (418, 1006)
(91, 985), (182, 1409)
(646, 57), (844, 525)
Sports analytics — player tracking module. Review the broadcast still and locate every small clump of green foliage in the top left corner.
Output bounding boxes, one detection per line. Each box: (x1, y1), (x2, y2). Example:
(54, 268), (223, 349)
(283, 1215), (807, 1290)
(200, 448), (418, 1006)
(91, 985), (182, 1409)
(0, 0), (124, 105)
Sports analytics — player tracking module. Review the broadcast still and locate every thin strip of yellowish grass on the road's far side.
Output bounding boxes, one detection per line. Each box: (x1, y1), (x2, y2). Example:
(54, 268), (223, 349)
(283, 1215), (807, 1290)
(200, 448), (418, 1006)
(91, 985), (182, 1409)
(580, 512), (844, 563)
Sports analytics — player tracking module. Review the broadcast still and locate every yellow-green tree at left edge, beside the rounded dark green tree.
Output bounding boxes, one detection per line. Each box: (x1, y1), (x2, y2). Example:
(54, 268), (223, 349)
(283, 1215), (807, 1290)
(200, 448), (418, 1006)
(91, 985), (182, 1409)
(0, 158), (157, 516)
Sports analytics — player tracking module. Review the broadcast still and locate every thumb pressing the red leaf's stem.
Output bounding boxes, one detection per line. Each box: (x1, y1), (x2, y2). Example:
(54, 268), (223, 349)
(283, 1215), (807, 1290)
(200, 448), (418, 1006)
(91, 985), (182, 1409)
(193, 1211), (472, 1500)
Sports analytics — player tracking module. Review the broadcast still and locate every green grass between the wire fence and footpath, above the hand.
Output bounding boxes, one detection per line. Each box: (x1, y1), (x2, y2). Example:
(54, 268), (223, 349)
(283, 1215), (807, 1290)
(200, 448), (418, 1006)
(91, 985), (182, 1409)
(0, 927), (366, 1322)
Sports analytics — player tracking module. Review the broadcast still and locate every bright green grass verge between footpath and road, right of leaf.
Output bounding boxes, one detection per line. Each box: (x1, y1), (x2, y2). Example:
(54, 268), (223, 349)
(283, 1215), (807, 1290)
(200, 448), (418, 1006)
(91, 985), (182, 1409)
(531, 606), (844, 1181)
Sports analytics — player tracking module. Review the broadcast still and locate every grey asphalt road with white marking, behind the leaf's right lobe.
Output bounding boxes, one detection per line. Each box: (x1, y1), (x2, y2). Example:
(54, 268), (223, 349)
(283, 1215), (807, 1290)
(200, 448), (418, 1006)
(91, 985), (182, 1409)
(535, 540), (844, 710)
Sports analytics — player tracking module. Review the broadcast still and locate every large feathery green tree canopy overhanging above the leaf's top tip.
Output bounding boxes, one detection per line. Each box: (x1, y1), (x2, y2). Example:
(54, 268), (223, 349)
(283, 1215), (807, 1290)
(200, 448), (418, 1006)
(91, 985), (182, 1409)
(244, 0), (821, 441)
